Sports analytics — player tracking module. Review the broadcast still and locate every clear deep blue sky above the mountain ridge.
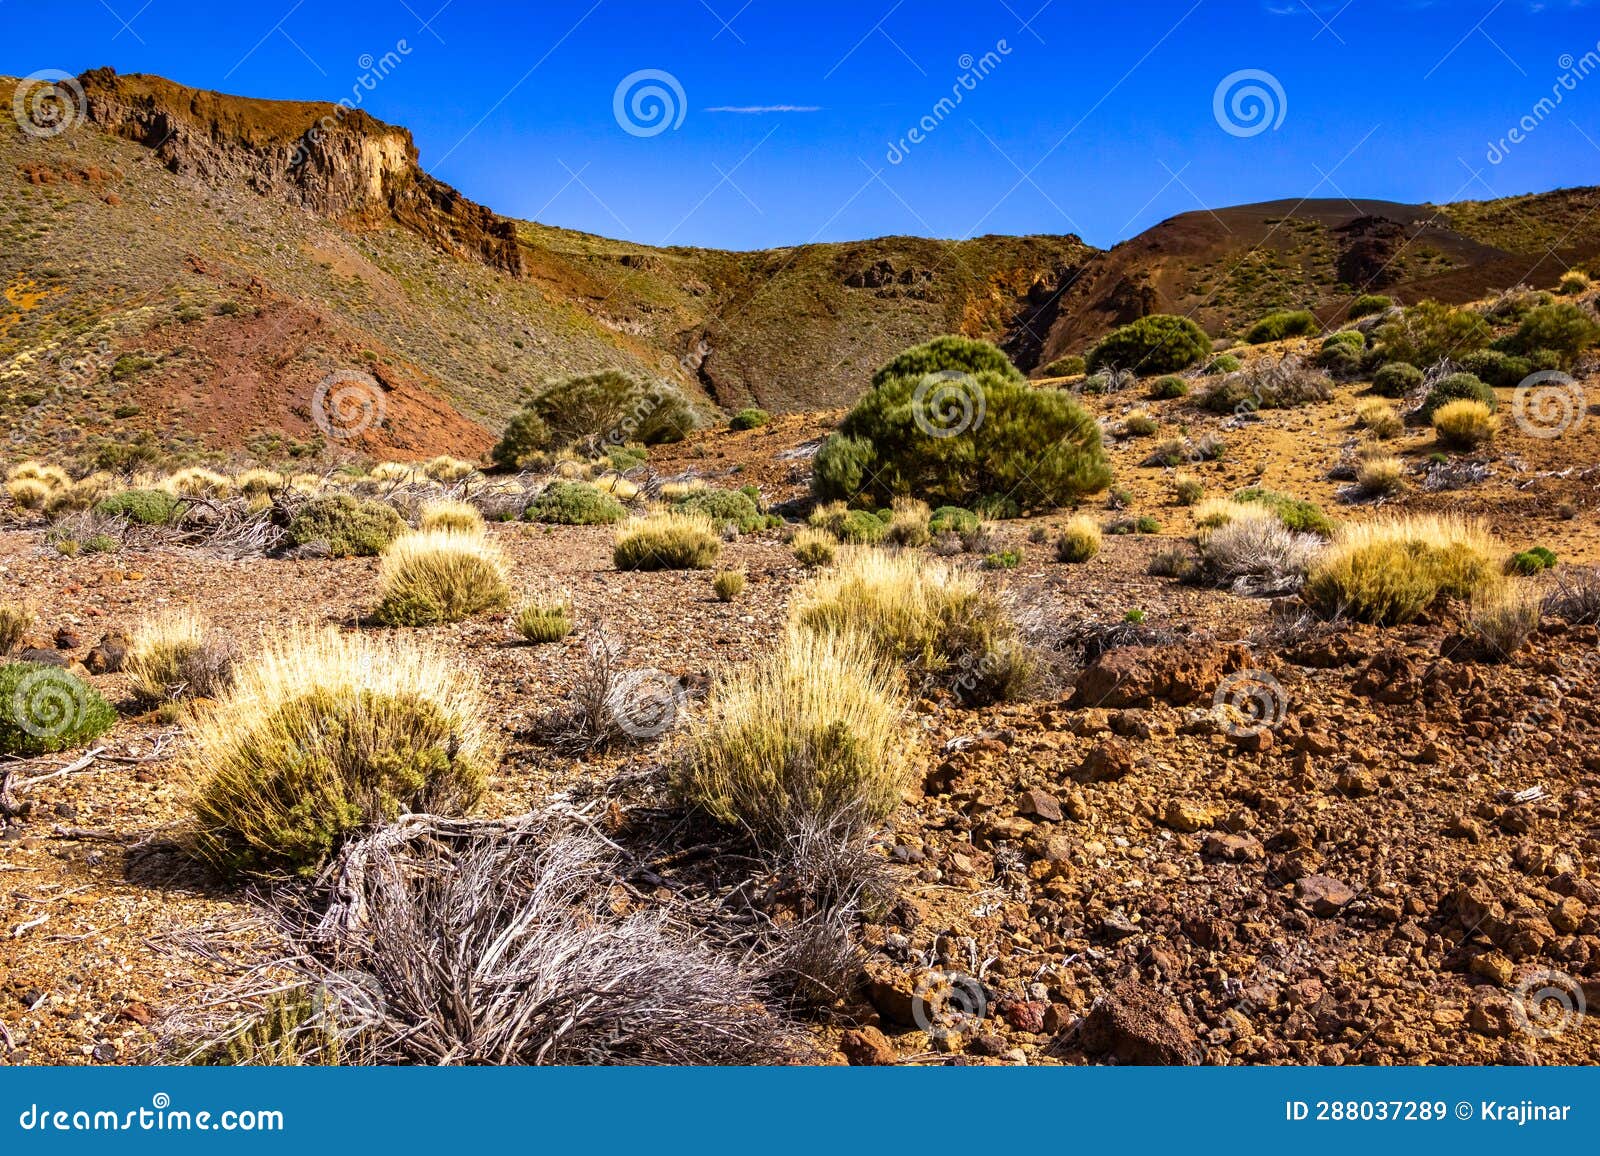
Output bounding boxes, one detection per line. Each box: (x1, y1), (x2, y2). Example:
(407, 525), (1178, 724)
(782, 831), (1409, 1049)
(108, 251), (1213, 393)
(0, 0), (1600, 248)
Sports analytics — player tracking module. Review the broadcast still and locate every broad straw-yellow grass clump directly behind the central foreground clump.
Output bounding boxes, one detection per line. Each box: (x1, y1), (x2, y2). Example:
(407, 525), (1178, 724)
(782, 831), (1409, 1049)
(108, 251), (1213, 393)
(790, 549), (1034, 703)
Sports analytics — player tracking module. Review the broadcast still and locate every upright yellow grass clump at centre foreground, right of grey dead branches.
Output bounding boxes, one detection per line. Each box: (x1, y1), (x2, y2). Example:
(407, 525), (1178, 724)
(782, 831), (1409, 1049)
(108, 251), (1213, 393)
(683, 629), (910, 847)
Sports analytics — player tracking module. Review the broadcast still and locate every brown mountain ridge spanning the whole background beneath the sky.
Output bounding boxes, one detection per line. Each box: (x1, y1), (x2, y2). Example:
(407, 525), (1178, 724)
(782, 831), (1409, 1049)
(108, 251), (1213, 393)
(0, 69), (1600, 461)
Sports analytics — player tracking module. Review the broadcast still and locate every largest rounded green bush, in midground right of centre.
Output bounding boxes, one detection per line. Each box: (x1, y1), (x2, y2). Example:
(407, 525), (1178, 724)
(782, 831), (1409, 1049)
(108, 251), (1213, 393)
(813, 370), (1110, 509)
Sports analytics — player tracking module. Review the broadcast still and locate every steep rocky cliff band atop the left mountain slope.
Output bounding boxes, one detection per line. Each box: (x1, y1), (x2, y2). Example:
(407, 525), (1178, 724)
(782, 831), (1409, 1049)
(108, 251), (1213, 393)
(78, 69), (523, 275)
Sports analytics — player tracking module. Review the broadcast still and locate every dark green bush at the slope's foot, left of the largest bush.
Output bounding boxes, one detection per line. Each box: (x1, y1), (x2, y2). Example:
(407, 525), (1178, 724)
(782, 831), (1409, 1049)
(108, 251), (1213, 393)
(491, 370), (696, 468)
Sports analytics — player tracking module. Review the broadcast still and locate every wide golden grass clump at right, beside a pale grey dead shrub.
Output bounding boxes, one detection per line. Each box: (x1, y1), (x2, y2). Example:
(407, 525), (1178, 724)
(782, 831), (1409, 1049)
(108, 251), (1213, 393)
(1306, 516), (1504, 626)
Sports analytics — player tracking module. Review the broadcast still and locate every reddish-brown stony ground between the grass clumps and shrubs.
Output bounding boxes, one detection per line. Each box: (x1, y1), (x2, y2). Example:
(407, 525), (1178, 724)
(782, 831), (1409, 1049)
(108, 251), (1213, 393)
(0, 382), (1600, 1063)
